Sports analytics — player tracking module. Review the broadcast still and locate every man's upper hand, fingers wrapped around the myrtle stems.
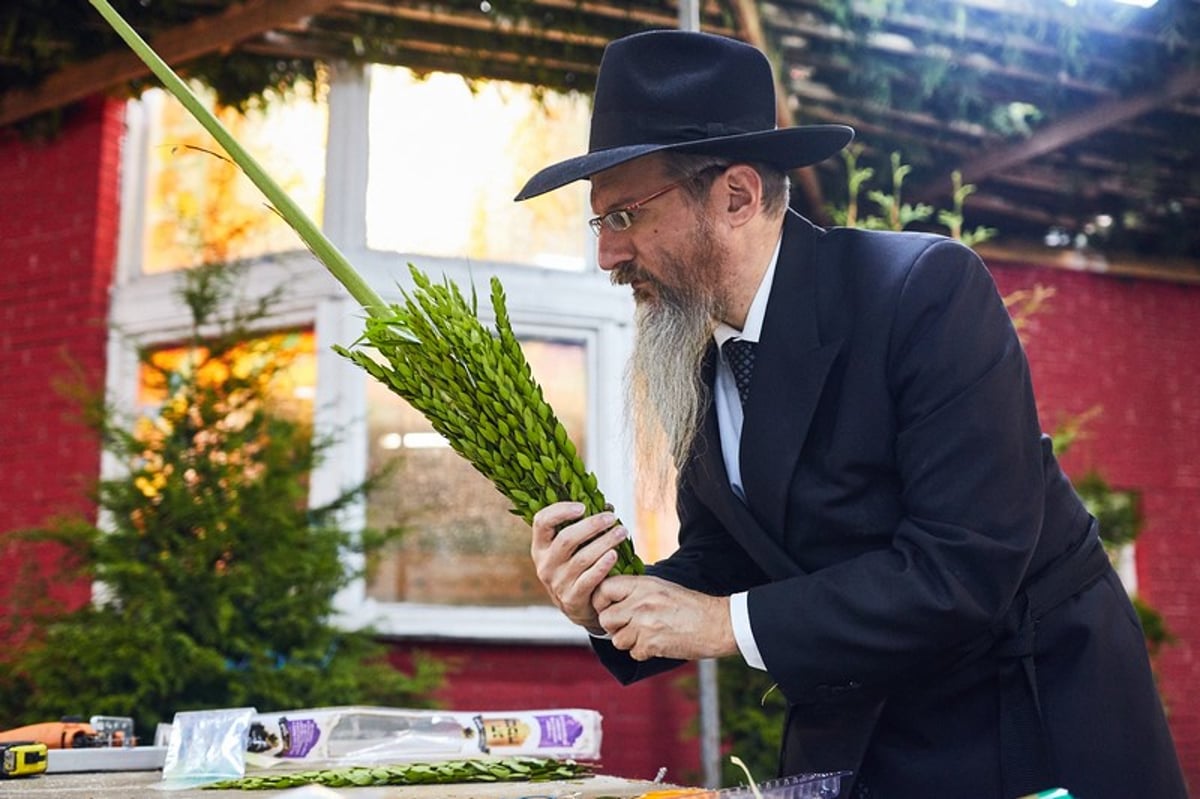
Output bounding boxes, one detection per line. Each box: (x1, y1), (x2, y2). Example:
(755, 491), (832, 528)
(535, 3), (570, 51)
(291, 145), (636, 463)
(529, 503), (629, 635)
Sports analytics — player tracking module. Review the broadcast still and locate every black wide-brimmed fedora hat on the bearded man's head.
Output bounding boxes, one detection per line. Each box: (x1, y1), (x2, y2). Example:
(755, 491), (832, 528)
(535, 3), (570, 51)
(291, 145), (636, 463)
(516, 30), (854, 200)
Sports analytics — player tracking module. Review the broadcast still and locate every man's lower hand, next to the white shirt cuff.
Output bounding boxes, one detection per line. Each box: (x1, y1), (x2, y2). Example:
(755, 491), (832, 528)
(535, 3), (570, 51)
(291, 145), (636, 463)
(593, 575), (738, 660)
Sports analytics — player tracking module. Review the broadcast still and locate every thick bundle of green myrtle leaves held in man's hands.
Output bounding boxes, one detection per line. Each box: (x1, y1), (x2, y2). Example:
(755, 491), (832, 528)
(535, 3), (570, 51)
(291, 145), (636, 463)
(335, 264), (643, 573)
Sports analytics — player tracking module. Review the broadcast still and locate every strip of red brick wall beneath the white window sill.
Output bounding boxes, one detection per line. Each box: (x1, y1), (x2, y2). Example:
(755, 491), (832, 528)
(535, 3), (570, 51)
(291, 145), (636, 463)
(397, 643), (701, 783)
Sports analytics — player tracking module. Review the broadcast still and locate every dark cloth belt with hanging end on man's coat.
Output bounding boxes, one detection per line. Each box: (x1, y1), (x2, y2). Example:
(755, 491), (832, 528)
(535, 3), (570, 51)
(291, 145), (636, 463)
(992, 523), (1112, 798)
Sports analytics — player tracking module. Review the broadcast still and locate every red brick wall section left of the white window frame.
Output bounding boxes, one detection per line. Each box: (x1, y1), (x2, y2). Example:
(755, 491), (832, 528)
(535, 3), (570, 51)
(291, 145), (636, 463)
(0, 101), (122, 611)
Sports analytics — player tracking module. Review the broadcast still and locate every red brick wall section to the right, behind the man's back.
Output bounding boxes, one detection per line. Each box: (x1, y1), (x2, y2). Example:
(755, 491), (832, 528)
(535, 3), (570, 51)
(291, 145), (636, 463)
(991, 257), (1200, 787)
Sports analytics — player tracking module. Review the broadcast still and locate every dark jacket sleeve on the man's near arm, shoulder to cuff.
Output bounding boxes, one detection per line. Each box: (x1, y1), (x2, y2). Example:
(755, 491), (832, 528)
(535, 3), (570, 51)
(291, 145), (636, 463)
(749, 240), (1044, 701)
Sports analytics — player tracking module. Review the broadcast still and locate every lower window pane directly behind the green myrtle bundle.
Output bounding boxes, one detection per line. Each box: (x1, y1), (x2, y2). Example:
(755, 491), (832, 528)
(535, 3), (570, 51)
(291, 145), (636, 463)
(367, 340), (587, 606)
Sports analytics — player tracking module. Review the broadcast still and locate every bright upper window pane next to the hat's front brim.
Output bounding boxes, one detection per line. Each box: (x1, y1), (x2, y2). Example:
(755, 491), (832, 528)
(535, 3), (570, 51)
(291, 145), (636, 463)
(367, 66), (592, 270)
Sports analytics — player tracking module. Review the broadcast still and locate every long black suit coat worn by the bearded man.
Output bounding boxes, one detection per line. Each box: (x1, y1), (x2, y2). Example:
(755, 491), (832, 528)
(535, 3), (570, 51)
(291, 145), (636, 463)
(595, 214), (1184, 799)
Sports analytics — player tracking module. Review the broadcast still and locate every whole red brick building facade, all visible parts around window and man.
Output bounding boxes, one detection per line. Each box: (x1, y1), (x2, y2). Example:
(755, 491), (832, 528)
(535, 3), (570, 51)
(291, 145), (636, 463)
(0, 102), (1200, 785)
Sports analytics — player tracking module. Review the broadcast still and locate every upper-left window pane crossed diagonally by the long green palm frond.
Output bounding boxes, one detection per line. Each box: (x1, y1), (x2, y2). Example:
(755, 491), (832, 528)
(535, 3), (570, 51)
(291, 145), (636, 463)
(142, 86), (329, 272)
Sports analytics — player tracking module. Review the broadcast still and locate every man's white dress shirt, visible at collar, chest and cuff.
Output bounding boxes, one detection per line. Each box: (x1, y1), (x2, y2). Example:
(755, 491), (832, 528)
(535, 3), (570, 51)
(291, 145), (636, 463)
(713, 239), (782, 671)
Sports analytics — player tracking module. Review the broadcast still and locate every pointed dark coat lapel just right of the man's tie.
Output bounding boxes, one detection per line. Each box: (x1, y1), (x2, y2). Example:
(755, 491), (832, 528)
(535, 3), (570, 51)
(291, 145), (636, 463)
(740, 214), (841, 541)
